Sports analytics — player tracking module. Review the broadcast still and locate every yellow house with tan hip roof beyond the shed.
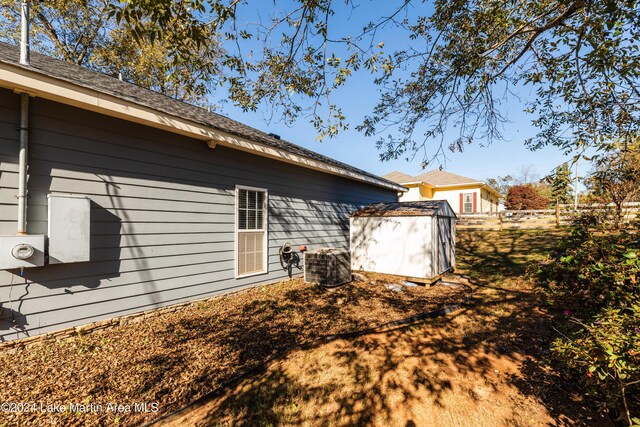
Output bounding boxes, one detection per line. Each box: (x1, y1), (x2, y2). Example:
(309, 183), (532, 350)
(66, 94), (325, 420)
(383, 170), (501, 214)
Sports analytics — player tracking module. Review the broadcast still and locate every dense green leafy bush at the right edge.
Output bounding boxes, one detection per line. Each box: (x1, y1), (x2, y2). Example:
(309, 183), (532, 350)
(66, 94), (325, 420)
(533, 218), (640, 425)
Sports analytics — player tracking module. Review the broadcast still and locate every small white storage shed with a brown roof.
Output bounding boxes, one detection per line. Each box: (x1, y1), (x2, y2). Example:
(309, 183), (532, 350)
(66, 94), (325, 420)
(350, 200), (456, 282)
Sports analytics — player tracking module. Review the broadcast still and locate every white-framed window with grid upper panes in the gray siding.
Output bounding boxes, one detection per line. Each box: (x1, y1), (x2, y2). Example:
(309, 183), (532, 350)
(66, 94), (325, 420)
(236, 186), (268, 277)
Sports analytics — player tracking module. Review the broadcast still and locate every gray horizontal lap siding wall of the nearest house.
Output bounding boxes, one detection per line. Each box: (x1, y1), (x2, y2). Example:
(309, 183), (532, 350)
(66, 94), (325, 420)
(0, 90), (396, 340)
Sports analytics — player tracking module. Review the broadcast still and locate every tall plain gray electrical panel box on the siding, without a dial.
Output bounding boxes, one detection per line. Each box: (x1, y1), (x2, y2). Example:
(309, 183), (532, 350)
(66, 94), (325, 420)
(47, 194), (91, 264)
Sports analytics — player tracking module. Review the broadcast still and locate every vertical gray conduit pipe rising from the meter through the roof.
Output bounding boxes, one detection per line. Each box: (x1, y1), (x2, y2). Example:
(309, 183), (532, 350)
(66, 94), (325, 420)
(18, 0), (30, 235)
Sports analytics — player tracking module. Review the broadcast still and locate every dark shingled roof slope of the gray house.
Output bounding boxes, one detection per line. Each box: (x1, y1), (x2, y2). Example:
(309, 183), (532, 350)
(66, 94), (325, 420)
(0, 42), (397, 191)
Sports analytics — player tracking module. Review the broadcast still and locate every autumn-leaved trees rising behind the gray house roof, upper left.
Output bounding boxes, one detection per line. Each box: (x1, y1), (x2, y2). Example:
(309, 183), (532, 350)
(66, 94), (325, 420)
(0, 0), (224, 106)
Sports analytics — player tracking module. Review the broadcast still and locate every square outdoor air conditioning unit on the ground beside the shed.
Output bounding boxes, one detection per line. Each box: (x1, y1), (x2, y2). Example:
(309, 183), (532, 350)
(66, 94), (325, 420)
(304, 248), (351, 287)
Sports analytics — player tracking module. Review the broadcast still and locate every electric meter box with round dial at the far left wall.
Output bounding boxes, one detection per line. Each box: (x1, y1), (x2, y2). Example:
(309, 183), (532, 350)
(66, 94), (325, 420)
(0, 234), (44, 270)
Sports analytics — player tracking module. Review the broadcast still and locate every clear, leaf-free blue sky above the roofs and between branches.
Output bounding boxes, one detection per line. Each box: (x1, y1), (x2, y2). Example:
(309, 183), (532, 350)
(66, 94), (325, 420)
(214, 0), (586, 185)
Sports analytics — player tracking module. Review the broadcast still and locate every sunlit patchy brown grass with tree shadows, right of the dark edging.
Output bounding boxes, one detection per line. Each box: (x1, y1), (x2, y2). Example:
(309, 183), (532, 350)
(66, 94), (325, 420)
(166, 230), (611, 426)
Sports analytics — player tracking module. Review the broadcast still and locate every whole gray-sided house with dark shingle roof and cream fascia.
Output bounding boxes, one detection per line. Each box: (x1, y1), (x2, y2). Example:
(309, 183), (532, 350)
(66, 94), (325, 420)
(0, 43), (403, 340)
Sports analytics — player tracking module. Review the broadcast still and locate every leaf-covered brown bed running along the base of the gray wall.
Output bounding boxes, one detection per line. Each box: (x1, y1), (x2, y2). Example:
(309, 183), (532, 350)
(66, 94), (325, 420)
(0, 276), (468, 426)
